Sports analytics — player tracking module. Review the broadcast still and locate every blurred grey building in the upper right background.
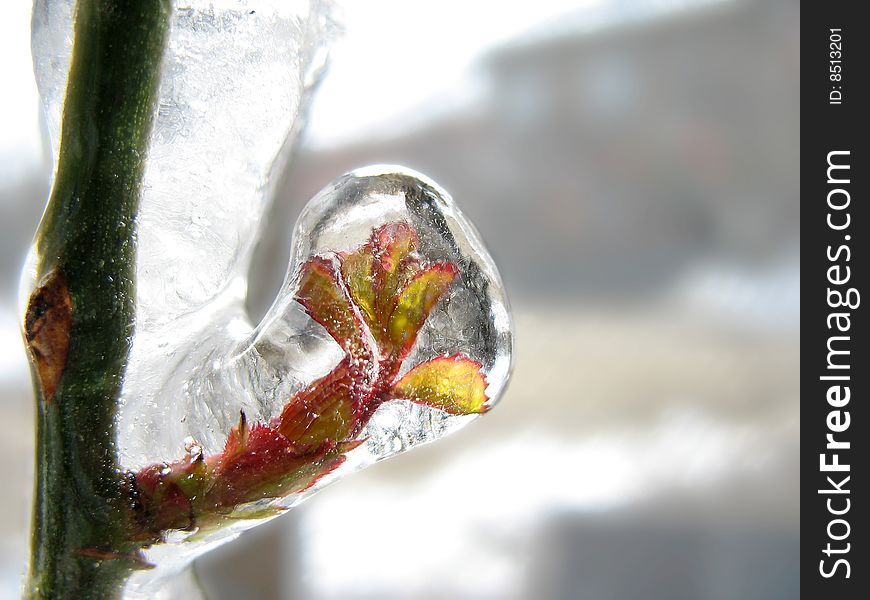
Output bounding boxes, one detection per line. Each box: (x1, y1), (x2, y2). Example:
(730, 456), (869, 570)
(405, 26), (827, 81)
(249, 0), (800, 312)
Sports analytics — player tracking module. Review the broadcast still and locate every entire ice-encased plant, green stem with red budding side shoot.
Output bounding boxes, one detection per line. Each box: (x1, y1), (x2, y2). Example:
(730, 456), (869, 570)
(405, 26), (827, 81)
(22, 0), (512, 598)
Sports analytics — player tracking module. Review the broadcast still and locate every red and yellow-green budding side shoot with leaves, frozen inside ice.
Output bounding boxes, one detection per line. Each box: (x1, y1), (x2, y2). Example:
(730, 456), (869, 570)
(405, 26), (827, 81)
(128, 222), (498, 544)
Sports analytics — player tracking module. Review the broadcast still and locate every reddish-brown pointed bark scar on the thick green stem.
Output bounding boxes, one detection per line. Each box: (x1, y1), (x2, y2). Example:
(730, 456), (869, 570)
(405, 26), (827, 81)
(24, 269), (73, 402)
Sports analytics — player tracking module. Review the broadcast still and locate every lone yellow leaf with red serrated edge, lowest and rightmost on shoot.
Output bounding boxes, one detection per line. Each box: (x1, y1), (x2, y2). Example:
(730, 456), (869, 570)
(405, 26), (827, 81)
(391, 354), (488, 415)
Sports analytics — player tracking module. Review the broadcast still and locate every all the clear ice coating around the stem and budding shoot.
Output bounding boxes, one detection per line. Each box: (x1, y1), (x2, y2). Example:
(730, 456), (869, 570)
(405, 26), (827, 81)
(33, 0), (512, 596)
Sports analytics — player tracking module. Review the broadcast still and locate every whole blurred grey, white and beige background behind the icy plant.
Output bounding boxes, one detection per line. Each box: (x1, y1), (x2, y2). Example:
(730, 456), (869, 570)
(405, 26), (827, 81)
(0, 0), (800, 600)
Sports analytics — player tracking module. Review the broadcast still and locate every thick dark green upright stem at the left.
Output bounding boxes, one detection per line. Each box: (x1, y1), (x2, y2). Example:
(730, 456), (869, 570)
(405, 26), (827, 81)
(25, 0), (172, 598)
